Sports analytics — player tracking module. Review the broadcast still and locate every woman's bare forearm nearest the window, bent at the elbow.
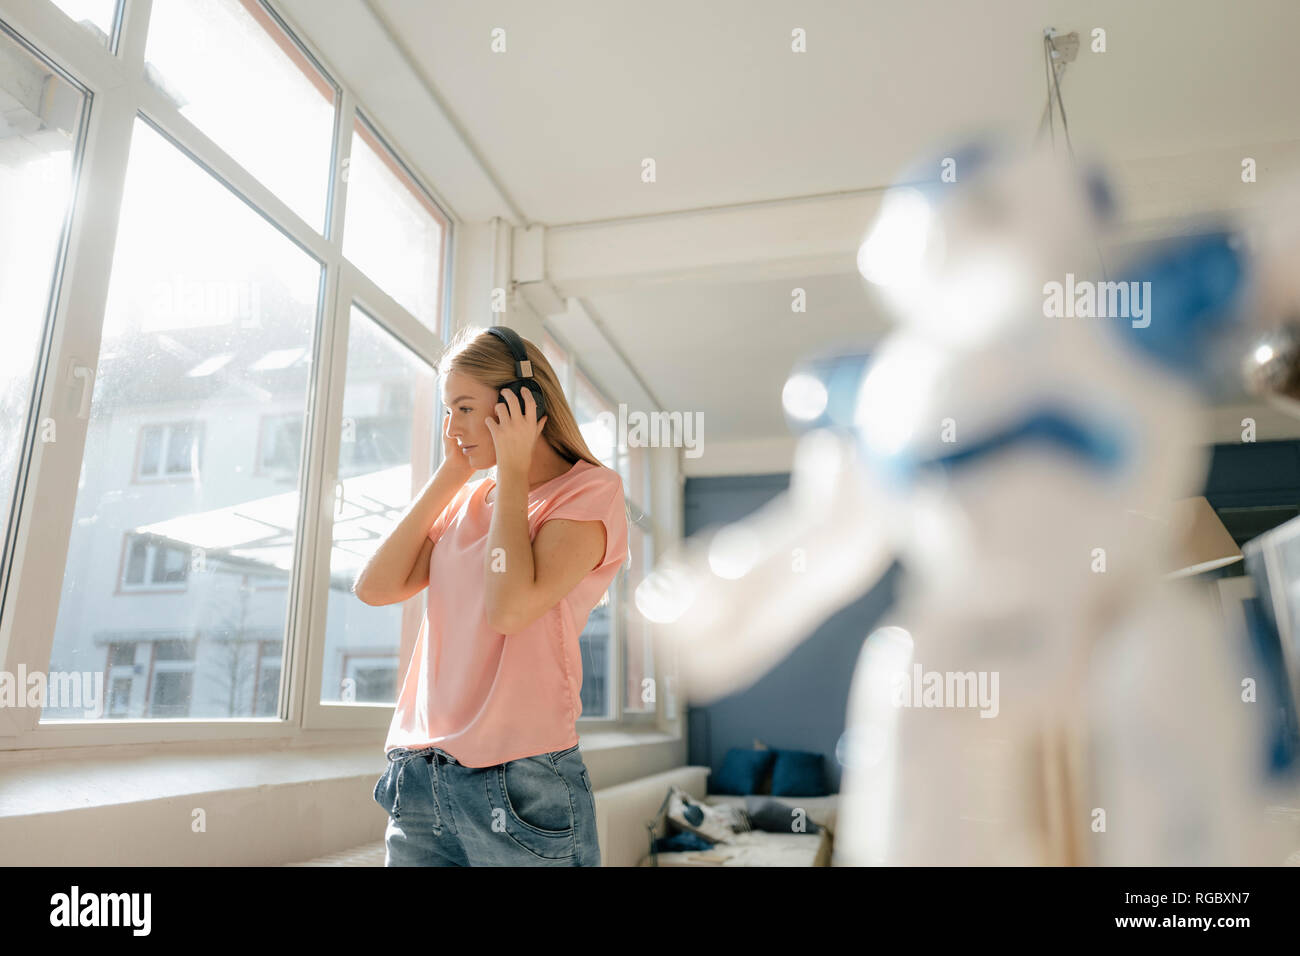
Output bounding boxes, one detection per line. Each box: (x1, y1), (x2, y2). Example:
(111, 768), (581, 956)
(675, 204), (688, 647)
(352, 459), (473, 607)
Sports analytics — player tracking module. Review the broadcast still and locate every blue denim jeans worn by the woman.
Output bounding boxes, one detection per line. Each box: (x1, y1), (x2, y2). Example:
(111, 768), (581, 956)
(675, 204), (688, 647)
(373, 744), (601, 866)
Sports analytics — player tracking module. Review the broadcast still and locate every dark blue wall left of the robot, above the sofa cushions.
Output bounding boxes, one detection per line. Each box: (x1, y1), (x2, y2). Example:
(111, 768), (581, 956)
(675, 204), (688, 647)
(684, 475), (898, 793)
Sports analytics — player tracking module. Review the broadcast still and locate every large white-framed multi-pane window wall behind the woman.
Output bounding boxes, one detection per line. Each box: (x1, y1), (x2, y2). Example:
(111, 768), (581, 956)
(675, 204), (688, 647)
(0, 0), (653, 749)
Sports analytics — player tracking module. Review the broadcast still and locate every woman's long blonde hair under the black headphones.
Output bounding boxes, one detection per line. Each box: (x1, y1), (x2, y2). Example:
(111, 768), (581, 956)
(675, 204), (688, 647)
(438, 325), (608, 468)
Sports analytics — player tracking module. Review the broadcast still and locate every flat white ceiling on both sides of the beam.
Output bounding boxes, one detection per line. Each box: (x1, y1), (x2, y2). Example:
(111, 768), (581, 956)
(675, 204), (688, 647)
(340, 0), (1300, 470)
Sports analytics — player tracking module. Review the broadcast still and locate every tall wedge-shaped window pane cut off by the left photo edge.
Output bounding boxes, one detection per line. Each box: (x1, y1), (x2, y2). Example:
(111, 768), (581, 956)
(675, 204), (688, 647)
(0, 33), (85, 574)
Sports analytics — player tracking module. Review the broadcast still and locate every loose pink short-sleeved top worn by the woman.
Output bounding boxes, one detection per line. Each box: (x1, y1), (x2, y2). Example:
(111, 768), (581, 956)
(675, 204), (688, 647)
(384, 459), (628, 767)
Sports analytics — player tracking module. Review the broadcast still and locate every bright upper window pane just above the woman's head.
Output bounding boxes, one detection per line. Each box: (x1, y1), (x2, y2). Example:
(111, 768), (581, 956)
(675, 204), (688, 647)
(343, 120), (446, 332)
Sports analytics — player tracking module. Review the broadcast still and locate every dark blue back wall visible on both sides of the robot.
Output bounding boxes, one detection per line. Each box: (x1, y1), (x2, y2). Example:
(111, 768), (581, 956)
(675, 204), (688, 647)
(684, 441), (1300, 793)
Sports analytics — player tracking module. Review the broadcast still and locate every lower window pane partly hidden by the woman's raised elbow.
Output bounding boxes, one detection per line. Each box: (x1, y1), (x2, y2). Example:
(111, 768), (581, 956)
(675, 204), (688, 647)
(321, 307), (439, 704)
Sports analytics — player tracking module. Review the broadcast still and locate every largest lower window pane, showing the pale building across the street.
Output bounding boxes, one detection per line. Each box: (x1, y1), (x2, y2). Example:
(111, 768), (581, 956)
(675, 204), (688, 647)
(43, 121), (321, 719)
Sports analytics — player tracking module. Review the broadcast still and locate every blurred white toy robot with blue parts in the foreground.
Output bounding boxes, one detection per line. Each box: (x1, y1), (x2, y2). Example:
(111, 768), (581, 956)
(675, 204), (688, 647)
(637, 146), (1300, 865)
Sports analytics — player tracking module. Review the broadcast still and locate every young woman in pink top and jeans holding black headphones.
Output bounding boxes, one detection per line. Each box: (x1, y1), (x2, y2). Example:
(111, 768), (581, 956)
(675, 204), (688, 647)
(355, 326), (628, 866)
